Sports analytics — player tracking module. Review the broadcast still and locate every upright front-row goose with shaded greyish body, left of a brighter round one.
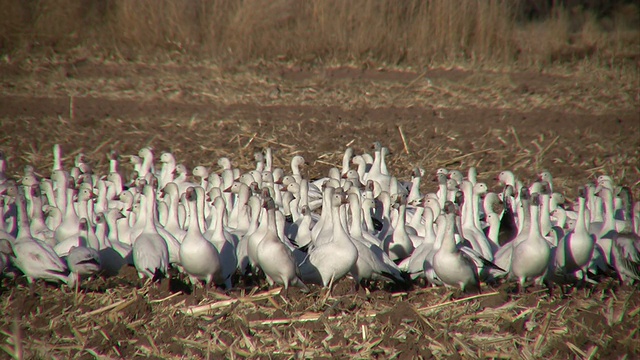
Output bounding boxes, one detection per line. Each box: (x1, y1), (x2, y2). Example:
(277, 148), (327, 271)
(132, 185), (169, 279)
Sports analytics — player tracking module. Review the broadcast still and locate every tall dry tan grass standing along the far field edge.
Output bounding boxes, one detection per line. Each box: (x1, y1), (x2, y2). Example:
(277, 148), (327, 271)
(0, 0), (640, 68)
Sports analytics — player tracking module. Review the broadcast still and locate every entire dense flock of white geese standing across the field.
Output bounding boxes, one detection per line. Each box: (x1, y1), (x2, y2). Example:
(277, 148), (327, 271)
(0, 143), (640, 292)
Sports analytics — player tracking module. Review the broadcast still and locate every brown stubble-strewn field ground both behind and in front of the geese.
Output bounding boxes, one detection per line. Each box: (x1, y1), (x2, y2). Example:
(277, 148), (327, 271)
(0, 58), (640, 359)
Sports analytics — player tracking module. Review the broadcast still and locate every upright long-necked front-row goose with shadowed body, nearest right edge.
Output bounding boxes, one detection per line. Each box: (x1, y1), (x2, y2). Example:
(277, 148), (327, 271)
(554, 188), (595, 282)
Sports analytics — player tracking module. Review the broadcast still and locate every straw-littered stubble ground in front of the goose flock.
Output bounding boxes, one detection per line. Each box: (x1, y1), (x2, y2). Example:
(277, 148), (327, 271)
(0, 271), (640, 359)
